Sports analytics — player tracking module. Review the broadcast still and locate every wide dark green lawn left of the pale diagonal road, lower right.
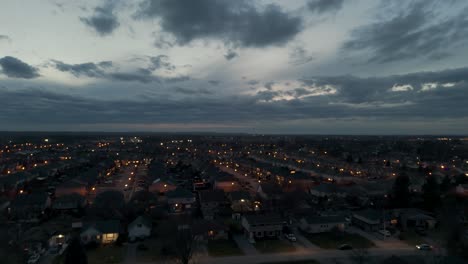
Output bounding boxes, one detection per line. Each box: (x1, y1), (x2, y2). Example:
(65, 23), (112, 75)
(303, 232), (375, 249)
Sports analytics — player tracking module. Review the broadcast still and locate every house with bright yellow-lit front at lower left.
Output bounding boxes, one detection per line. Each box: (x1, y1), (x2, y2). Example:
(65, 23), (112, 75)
(80, 220), (121, 244)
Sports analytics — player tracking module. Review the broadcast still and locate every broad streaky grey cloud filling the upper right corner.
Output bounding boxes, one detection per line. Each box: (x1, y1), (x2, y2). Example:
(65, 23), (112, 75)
(343, 0), (468, 63)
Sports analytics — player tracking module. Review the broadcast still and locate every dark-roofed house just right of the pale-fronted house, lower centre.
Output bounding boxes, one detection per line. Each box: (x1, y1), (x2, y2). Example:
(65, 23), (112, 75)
(198, 190), (227, 220)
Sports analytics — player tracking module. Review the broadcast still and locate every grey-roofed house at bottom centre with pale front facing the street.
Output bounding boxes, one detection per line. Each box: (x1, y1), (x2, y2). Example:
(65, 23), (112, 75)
(241, 213), (284, 242)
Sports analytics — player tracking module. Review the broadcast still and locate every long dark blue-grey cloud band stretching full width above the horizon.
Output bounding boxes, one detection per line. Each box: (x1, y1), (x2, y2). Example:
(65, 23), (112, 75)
(0, 68), (468, 129)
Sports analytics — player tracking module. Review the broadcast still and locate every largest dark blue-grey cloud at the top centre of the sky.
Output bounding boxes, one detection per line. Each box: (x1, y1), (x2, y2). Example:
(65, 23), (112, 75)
(136, 0), (302, 47)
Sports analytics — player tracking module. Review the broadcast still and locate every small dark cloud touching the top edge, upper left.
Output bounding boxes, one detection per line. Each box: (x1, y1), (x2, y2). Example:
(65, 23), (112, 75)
(80, 1), (120, 36)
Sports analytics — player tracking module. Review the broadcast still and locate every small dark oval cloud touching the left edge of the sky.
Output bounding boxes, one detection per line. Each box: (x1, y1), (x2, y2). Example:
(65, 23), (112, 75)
(0, 56), (39, 79)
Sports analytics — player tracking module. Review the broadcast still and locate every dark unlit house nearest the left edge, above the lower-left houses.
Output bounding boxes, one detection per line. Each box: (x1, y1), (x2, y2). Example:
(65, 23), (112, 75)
(8, 192), (51, 222)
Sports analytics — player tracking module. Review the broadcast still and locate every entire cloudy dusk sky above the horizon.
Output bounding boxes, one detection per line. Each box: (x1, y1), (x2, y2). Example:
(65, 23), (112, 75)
(0, 0), (468, 135)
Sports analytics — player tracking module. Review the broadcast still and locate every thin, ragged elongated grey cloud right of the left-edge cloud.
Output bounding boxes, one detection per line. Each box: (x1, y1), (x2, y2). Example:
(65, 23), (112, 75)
(52, 60), (112, 78)
